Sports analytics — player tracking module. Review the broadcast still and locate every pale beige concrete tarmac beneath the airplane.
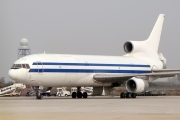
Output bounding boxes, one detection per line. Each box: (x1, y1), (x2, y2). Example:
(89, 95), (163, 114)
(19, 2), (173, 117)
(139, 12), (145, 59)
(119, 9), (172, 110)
(0, 96), (180, 120)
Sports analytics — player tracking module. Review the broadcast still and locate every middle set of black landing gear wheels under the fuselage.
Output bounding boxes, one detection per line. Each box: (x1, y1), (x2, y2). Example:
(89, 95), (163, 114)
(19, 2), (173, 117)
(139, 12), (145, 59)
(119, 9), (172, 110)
(72, 87), (88, 98)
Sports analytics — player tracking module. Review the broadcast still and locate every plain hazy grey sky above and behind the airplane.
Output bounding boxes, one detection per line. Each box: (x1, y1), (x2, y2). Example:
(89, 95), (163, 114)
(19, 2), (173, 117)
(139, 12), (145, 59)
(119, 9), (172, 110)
(0, 0), (180, 81)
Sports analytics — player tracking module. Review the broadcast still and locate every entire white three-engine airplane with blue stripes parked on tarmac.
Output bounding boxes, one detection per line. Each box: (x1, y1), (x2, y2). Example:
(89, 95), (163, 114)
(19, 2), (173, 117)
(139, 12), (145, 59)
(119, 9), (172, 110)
(8, 14), (180, 99)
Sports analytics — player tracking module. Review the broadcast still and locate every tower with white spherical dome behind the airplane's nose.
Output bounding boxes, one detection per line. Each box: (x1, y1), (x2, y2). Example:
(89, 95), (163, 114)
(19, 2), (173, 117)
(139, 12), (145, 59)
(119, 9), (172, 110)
(18, 38), (31, 58)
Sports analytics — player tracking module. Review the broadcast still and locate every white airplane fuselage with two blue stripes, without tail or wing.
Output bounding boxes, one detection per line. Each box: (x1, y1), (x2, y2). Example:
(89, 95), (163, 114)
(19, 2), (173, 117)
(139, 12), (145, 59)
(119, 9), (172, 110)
(9, 54), (153, 87)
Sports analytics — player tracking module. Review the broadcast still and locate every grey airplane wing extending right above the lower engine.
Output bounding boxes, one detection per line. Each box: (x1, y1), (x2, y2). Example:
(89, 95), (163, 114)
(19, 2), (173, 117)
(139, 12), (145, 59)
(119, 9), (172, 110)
(93, 69), (180, 83)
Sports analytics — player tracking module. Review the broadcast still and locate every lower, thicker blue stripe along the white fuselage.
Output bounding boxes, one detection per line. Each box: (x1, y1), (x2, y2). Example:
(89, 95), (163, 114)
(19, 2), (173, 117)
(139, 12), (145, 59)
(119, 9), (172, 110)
(29, 69), (151, 73)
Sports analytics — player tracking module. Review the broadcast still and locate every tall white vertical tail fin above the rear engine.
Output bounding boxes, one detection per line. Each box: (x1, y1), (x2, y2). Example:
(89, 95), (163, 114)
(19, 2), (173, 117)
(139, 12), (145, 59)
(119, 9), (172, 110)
(146, 14), (165, 51)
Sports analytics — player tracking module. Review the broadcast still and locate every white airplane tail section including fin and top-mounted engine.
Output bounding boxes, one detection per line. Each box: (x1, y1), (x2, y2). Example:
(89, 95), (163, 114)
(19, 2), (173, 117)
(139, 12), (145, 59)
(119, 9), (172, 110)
(124, 14), (166, 69)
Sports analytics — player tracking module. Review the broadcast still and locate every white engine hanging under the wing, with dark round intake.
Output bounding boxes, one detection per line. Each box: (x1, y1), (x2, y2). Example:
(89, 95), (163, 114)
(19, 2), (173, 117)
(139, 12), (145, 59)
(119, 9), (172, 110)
(126, 78), (149, 93)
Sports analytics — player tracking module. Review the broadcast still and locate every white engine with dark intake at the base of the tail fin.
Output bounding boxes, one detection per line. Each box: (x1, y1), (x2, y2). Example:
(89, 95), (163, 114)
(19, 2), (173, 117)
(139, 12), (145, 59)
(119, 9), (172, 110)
(124, 41), (146, 53)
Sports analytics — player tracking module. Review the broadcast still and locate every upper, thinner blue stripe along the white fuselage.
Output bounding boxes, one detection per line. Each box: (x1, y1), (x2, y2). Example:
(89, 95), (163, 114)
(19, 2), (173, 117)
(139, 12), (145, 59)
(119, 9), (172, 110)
(33, 62), (150, 67)
